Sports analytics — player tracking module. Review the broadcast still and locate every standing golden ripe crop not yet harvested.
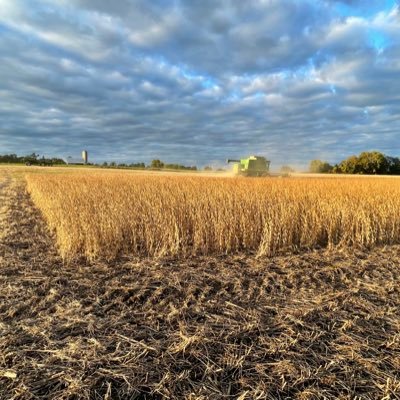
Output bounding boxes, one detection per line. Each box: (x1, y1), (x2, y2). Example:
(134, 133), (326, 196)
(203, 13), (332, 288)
(27, 173), (400, 260)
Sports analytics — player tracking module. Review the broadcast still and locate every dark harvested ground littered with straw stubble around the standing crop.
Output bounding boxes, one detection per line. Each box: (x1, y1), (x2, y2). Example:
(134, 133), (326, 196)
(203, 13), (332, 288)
(0, 171), (400, 400)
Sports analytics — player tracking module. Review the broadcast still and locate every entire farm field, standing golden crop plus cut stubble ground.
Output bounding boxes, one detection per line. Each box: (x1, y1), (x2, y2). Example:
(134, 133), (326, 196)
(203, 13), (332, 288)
(0, 167), (400, 400)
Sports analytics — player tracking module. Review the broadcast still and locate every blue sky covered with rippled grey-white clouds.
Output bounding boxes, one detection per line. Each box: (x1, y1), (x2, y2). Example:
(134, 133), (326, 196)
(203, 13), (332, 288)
(0, 0), (400, 169)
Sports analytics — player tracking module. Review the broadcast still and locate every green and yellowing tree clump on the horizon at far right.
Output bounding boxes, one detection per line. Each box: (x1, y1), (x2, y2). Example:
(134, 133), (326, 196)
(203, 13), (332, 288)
(309, 151), (400, 175)
